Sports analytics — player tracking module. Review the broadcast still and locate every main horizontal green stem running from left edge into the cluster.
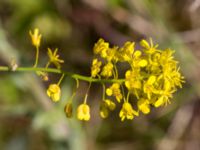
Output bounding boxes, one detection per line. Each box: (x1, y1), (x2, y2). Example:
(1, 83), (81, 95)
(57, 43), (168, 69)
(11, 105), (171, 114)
(0, 66), (125, 83)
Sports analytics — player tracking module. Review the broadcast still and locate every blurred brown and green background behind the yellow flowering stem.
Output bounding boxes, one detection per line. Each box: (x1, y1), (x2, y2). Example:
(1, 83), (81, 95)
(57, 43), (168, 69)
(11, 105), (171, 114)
(0, 0), (200, 150)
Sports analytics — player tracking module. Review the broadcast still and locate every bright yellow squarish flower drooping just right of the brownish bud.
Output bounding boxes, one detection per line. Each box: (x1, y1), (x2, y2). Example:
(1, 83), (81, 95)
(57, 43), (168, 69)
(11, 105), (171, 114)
(77, 104), (90, 121)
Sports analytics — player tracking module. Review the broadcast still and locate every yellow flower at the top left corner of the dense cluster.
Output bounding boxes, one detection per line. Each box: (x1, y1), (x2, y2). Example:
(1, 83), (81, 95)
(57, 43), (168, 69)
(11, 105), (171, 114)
(93, 39), (109, 58)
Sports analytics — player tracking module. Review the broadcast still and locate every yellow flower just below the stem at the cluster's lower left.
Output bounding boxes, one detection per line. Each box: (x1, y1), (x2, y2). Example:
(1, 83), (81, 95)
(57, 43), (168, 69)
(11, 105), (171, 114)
(106, 83), (122, 102)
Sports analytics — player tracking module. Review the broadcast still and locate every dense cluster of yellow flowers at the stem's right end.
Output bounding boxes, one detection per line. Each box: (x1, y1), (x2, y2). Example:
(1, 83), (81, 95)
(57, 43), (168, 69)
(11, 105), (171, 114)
(91, 39), (184, 121)
